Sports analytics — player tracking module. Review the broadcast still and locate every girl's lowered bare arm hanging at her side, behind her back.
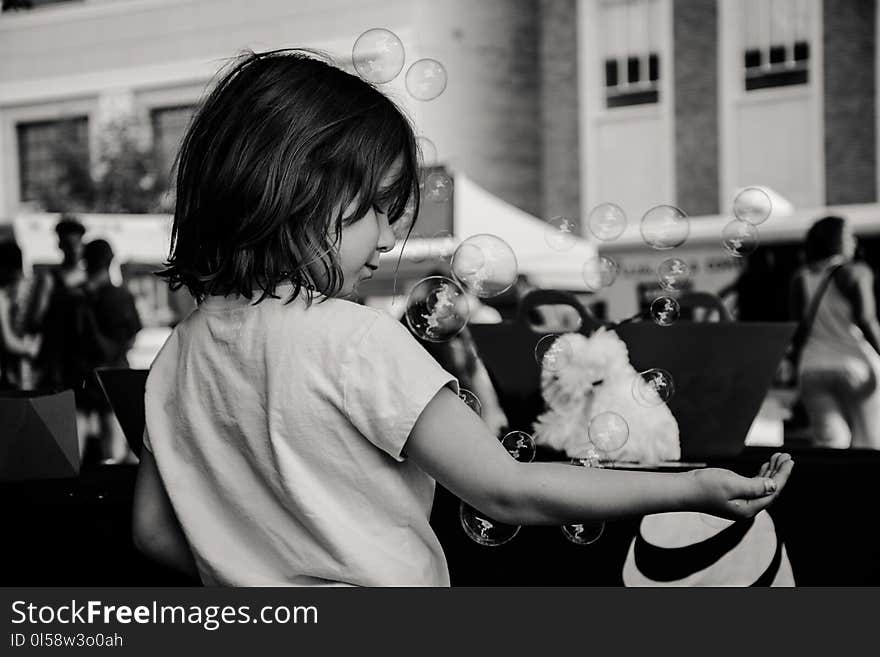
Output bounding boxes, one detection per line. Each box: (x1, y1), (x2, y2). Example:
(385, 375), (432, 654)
(132, 448), (199, 580)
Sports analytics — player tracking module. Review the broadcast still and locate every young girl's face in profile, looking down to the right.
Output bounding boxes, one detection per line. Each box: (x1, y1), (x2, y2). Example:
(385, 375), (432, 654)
(338, 165), (395, 297)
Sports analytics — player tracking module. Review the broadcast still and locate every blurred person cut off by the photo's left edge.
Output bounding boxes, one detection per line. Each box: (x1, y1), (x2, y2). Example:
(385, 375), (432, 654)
(0, 240), (39, 390)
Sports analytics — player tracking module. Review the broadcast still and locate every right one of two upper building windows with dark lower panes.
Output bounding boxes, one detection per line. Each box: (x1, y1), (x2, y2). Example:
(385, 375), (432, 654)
(740, 0), (812, 91)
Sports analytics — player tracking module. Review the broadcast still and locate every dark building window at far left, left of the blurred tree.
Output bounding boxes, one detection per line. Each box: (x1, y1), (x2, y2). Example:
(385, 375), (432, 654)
(16, 116), (90, 201)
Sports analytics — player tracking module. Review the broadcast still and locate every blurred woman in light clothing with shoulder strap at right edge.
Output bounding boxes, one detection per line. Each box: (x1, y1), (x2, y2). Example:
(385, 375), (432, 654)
(791, 216), (880, 449)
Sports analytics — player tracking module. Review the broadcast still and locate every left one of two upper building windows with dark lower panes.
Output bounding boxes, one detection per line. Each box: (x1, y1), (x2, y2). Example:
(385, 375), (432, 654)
(599, 0), (660, 108)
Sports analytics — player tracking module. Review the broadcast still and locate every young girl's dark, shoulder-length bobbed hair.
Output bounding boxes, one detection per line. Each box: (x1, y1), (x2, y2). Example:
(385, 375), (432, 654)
(159, 49), (419, 302)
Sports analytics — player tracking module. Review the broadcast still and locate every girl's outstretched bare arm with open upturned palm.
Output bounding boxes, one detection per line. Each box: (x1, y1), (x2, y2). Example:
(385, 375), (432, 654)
(404, 388), (793, 525)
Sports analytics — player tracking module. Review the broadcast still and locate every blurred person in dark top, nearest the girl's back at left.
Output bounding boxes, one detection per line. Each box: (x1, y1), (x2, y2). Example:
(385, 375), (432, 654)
(74, 239), (141, 464)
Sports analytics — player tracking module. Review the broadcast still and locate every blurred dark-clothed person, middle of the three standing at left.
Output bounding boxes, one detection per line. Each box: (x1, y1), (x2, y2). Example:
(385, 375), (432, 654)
(27, 215), (86, 390)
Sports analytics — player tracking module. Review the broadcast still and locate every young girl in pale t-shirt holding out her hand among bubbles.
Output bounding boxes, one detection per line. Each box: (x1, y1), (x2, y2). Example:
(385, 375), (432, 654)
(134, 51), (792, 586)
